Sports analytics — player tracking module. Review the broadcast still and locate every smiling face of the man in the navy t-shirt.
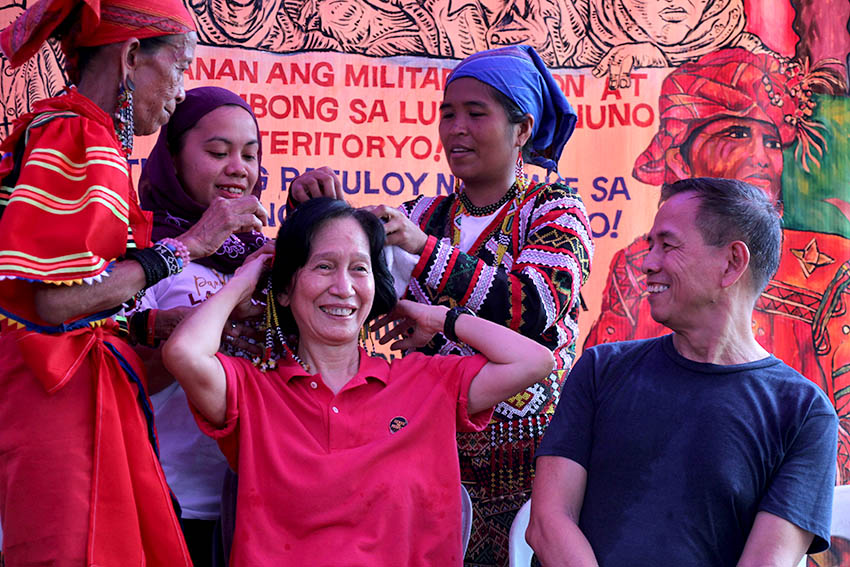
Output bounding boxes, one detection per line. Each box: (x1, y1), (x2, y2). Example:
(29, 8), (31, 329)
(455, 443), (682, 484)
(642, 192), (726, 331)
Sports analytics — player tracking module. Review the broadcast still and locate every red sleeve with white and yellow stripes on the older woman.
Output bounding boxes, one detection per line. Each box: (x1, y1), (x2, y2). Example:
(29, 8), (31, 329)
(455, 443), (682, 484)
(0, 89), (150, 292)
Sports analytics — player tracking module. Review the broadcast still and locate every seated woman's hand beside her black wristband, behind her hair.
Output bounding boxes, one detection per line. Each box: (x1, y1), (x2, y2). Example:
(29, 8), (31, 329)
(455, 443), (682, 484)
(371, 299), (449, 350)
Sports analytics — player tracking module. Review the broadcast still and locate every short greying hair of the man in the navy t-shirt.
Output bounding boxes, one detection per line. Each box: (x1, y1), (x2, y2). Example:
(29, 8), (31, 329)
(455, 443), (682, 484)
(661, 177), (782, 292)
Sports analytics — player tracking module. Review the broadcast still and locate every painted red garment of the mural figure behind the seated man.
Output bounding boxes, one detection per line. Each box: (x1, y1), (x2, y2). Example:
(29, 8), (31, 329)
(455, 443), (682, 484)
(584, 229), (850, 484)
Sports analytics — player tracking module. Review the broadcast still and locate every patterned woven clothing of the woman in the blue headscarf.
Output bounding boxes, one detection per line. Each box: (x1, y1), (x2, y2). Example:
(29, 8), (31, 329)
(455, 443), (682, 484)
(403, 184), (593, 565)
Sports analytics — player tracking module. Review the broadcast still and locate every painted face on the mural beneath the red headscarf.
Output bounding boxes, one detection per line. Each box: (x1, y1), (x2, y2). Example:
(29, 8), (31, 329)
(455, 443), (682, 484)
(685, 116), (783, 205)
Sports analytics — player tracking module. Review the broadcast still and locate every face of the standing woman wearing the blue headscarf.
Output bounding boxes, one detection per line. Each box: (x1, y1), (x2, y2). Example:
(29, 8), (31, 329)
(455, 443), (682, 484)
(440, 77), (527, 193)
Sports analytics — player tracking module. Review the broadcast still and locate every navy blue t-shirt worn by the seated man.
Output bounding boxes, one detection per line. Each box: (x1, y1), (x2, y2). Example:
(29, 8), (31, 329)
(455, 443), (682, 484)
(536, 335), (838, 567)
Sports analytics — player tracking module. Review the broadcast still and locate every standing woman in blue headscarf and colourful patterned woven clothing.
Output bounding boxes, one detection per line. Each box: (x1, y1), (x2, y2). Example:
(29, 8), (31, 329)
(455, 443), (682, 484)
(373, 46), (593, 565)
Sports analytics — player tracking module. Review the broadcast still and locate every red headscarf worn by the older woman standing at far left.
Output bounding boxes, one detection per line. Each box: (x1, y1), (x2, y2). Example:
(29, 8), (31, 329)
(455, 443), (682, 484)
(0, 0), (195, 67)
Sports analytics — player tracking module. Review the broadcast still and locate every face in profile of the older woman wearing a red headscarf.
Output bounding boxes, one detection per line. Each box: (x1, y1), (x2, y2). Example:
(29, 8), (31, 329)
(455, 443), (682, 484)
(132, 32), (197, 136)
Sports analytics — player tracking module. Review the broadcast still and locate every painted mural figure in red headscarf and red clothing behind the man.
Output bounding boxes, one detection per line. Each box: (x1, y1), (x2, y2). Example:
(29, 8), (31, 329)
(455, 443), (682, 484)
(584, 49), (850, 482)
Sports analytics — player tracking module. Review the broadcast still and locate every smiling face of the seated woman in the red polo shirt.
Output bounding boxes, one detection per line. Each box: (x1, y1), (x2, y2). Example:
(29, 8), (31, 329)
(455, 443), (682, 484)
(278, 217), (375, 346)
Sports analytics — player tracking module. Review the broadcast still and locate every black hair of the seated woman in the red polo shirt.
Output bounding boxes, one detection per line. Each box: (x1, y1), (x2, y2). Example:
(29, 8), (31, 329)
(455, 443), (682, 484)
(272, 197), (396, 335)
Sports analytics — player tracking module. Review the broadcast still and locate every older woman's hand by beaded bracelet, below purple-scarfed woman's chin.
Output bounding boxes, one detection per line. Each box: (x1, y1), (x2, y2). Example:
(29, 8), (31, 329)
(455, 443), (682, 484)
(178, 195), (268, 259)
